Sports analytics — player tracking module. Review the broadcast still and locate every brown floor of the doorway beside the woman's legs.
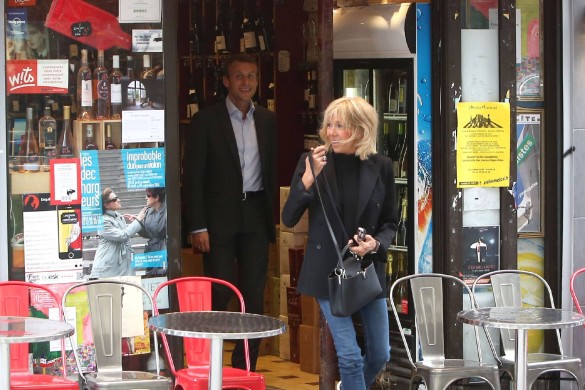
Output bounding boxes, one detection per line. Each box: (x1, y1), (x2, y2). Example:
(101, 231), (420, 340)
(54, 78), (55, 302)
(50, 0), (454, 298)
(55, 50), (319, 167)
(223, 342), (319, 390)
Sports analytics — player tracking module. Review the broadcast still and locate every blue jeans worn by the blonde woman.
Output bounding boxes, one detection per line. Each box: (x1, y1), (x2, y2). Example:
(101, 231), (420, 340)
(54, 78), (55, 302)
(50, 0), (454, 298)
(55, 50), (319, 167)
(317, 298), (390, 390)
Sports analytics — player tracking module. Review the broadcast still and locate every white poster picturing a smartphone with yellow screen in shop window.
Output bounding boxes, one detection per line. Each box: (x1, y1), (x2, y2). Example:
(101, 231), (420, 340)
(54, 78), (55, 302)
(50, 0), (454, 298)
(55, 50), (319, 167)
(22, 193), (82, 284)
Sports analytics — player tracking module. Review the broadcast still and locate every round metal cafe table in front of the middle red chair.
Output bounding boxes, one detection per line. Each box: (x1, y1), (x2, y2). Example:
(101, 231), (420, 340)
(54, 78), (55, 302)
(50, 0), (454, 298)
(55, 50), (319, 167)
(148, 311), (286, 390)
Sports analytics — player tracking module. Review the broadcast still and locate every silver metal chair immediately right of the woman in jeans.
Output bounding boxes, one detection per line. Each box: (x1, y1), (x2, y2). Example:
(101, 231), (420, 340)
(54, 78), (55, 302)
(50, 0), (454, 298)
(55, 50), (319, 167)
(390, 273), (500, 390)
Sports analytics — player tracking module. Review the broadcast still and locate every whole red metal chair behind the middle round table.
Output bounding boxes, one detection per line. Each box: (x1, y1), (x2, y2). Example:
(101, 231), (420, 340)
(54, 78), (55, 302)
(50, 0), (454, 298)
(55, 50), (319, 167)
(153, 276), (266, 390)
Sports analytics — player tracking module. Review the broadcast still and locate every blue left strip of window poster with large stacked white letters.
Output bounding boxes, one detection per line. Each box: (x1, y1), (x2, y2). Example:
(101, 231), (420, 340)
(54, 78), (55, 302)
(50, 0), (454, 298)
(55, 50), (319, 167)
(79, 150), (102, 233)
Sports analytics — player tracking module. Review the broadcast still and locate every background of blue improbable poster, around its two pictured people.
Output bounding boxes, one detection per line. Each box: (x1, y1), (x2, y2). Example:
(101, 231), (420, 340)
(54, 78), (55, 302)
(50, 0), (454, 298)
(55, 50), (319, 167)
(80, 148), (168, 276)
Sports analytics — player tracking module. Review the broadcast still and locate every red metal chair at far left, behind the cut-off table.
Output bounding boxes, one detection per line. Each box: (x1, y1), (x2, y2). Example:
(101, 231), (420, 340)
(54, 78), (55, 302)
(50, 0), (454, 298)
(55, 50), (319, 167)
(0, 281), (79, 390)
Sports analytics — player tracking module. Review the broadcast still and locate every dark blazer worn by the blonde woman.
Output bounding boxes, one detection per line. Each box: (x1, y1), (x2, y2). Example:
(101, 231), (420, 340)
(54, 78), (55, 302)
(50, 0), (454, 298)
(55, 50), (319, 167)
(282, 153), (398, 298)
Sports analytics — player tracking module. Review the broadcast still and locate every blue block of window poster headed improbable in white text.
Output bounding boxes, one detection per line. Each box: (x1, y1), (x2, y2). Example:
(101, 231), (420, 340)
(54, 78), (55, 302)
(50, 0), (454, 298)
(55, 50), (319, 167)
(121, 148), (165, 190)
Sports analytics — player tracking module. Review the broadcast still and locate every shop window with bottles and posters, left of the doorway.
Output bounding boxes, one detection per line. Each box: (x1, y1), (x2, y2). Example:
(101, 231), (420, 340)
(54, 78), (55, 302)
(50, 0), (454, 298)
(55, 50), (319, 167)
(0, 0), (180, 372)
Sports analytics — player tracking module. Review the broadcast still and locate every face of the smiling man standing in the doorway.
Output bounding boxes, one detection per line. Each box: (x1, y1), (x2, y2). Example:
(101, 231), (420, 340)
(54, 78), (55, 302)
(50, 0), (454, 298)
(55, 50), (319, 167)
(223, 62), (258, 106)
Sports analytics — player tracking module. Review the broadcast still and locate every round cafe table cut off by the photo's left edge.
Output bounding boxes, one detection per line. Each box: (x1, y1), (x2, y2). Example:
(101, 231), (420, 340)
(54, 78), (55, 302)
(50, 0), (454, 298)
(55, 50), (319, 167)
(0, 316), (74, 390)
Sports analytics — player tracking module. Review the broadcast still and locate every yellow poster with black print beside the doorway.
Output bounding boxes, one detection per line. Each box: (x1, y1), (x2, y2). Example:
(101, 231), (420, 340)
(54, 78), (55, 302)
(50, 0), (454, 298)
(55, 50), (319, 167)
(457, 102), (510, 188)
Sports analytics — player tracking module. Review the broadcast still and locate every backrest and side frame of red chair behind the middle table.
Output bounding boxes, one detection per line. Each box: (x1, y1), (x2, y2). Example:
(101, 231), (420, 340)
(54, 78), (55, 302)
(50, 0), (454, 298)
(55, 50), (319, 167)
(153, 276), (250, 375)
